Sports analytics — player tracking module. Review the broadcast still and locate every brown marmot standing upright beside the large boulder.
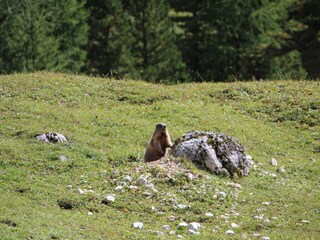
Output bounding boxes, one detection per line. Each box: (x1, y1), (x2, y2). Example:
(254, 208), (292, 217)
(144, 123), (172, 162)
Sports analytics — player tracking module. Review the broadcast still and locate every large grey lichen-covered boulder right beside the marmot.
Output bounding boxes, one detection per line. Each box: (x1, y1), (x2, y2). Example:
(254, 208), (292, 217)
(172, 131), (249, 177)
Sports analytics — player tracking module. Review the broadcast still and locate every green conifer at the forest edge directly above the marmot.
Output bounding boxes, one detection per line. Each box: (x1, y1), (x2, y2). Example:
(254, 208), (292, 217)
(125, 0), (188, 82)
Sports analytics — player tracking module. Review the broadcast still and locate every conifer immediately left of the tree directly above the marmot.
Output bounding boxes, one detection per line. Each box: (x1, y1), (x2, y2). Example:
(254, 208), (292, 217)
(86, 0), (135, 78)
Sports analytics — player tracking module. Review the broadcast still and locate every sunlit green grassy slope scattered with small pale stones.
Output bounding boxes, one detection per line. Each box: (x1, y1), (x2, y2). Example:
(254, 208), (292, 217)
(0, 72), (320, 239)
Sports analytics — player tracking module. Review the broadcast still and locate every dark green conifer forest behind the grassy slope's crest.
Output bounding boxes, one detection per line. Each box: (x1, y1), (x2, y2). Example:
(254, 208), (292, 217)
(0, 0), (320, 83)
